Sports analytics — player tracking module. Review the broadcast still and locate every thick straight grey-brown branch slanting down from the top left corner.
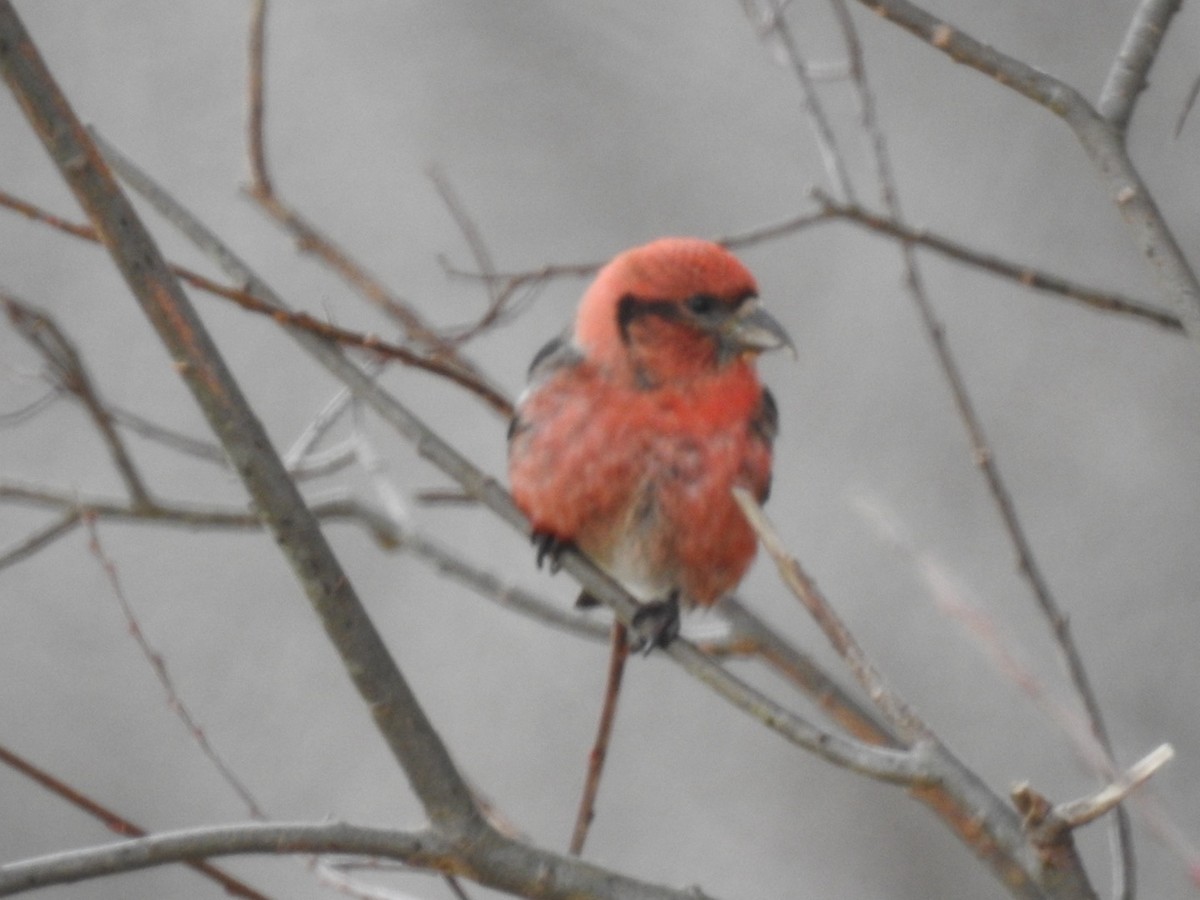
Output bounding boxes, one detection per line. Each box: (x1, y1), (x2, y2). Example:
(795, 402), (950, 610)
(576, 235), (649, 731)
(0, 0), (487, 836)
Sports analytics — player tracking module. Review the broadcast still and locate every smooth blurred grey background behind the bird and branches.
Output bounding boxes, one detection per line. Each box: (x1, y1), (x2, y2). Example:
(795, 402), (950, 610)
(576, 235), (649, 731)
(0, 0), (1200, 900)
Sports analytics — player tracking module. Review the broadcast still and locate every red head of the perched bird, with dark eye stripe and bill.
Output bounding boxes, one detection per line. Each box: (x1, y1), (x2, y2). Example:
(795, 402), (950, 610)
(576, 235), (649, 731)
(575, 238), (796, 384)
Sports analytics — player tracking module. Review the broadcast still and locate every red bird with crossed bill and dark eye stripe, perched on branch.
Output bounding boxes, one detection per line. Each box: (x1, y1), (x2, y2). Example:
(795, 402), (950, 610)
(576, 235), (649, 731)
(509, 238), (794, 646)
